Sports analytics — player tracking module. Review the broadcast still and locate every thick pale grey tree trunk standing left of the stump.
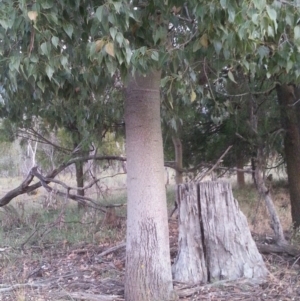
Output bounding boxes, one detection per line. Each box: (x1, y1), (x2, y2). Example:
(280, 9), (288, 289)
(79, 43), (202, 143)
(125, 72), (174, 301)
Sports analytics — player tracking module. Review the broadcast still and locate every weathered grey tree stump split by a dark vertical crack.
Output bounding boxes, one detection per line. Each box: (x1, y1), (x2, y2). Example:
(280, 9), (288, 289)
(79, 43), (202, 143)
(172, 182), (268, 283)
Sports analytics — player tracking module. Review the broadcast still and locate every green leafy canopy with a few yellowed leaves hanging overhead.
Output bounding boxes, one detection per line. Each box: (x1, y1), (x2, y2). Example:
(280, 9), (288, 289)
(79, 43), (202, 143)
(0, 0), (300, 149)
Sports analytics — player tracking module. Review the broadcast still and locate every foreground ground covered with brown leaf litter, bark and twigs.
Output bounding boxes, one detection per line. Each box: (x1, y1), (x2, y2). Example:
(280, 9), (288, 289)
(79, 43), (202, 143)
(0, 220), (300, 301)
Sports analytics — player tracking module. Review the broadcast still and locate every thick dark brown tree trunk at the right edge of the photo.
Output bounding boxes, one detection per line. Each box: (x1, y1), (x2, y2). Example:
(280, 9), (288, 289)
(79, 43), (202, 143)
(277, 85), (300, 228)
